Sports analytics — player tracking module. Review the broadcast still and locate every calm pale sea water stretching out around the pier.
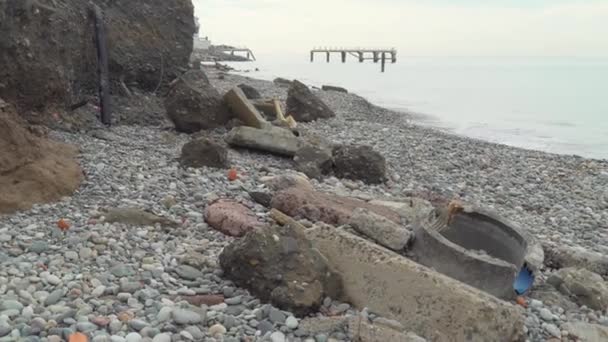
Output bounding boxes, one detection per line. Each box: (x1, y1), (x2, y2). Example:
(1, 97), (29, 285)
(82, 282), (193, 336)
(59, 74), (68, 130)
(224, 53), (608, 159)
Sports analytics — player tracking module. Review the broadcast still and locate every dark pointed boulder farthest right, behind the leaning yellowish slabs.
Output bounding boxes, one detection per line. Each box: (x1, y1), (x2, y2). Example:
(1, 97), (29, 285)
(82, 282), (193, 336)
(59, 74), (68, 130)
(287, 80), (336, 122)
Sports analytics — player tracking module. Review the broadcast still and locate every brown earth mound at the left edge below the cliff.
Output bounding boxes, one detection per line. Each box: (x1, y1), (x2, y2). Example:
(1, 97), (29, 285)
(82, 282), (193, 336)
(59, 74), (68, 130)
(0, 100), (83, 213)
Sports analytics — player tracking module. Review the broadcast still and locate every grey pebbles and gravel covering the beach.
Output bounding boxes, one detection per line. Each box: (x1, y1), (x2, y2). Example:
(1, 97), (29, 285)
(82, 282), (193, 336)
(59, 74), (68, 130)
(0, 67), (608, 342)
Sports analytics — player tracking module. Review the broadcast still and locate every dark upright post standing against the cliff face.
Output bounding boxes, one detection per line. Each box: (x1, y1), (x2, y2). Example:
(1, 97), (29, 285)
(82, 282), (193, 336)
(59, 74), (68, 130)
(93, 5), (112, 126)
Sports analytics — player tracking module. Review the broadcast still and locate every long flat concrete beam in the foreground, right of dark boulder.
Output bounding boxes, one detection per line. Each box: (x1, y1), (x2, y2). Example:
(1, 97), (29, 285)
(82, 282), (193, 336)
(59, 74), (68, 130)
(306, 226), (524, 342)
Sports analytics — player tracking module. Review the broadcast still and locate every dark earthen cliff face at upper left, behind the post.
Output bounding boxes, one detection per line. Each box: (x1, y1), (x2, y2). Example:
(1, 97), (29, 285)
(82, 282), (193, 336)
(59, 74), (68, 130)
(0, 0), (196, 113)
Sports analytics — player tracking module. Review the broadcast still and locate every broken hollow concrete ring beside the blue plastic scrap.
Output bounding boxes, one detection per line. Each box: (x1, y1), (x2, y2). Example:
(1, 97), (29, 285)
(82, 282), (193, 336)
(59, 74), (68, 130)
(409, 204), (527, 299)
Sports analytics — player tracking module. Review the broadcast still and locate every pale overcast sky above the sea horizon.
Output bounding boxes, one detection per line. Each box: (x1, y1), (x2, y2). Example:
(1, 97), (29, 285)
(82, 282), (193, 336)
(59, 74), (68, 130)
(193, 0), (608, 57)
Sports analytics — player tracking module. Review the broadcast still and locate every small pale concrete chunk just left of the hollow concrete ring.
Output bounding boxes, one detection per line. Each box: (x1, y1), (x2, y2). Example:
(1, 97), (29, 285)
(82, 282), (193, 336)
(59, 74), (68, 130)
(349, 208), (412, 251)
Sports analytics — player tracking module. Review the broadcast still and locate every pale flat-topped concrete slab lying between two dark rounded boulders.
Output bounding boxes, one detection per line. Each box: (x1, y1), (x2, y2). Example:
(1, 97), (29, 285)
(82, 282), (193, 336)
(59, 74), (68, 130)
(226, 126), (303, 157)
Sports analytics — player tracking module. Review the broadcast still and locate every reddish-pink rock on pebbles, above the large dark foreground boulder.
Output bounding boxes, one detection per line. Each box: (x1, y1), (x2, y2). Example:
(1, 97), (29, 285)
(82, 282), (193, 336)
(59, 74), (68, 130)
(205, 201), (262, 237)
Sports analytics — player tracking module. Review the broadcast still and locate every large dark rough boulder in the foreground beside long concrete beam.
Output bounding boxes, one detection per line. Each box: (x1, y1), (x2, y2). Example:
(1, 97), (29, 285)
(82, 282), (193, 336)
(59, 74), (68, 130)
(220, 225), (342, 315)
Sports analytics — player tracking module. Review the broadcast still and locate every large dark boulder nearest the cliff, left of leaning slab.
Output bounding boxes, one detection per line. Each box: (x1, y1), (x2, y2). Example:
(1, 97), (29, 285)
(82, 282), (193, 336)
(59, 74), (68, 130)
(165, 70), (232, 133)
